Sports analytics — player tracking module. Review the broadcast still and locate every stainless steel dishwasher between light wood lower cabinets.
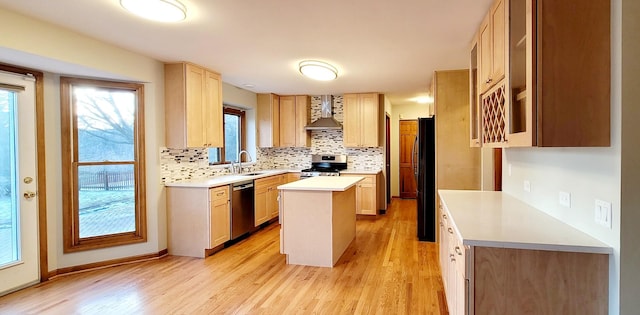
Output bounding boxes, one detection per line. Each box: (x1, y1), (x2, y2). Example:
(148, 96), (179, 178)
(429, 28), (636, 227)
(231, 180), (255, 240)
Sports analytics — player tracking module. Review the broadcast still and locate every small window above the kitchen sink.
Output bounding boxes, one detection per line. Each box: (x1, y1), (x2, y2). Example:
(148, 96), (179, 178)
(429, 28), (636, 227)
(209, 107), (245, 164)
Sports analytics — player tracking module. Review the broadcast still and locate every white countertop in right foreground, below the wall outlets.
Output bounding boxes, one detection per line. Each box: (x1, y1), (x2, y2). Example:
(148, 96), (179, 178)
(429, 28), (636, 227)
(438, 190), (613, 254)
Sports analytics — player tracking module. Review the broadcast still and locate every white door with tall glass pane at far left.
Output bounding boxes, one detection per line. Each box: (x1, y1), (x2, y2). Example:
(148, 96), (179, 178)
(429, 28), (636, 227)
(0, 72), (40, 295)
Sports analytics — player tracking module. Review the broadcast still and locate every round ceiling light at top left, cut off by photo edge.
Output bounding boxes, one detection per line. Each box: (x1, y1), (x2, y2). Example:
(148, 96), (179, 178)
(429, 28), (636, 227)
(120, 0), (187, 22)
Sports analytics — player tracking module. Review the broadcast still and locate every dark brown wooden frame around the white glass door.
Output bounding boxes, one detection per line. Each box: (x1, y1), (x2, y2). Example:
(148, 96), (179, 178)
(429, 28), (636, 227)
(0, 63), (49, 282)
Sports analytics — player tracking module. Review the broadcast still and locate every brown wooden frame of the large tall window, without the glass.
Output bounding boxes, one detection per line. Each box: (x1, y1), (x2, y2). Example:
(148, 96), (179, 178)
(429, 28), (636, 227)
(60, 77), (147, 253)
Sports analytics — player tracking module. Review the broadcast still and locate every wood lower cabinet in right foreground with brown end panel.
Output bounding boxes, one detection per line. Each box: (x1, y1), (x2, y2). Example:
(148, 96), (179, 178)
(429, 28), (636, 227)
(438, 199), (609, 315)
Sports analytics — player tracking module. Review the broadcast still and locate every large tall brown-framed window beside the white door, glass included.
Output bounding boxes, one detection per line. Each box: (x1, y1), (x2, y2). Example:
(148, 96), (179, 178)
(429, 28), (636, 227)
(60, 77), (146, 252)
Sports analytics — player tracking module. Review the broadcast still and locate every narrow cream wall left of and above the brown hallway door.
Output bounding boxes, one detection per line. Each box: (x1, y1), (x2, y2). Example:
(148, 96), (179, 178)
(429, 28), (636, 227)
(390, 104), (433, 197)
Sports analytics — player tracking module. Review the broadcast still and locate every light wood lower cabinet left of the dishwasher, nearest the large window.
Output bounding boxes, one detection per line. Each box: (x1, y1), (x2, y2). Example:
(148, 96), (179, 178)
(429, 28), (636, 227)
(167, 185), (231, 258)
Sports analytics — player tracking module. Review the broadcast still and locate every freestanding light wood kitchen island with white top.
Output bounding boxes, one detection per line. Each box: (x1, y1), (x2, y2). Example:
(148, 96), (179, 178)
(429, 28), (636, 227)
(278, 176), (364, 267)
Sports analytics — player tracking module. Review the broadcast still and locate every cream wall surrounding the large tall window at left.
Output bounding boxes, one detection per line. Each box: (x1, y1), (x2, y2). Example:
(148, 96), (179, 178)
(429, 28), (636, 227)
(0, 9), (167, 270)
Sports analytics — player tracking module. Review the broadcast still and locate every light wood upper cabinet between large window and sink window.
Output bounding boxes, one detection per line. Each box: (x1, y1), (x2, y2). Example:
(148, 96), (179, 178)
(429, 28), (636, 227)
(164, 62), (224, 148)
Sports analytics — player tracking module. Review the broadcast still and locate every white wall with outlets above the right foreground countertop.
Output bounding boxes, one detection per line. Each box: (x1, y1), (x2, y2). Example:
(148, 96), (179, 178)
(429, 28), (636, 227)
(503, 0), (624, 314)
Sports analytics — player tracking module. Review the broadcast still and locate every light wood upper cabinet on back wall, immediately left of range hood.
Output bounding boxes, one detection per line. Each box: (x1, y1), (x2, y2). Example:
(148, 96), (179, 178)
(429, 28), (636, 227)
(280, 95), (311, 147)
